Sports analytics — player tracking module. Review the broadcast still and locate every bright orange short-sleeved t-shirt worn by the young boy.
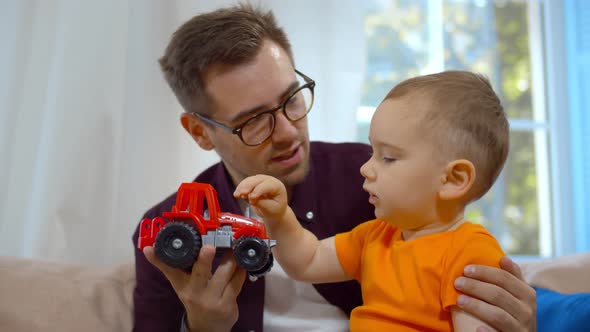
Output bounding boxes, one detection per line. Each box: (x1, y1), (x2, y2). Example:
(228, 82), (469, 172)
(335, 220), (504, 331)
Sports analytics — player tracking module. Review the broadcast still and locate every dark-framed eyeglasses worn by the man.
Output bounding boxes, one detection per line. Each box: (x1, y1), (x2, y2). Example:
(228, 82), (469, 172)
(194, 69), (315, 146)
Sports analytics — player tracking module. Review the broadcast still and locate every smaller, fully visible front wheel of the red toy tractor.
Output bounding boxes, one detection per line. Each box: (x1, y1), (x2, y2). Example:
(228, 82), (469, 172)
(233, 236), (270, 272)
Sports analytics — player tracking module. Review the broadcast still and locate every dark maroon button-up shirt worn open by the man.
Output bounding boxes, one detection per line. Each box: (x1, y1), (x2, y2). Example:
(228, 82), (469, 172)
(133, 142), (375, 332)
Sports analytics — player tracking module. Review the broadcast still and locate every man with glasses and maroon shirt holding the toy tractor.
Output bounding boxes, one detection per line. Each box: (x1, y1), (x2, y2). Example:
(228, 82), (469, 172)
(133, 5), (535, 332)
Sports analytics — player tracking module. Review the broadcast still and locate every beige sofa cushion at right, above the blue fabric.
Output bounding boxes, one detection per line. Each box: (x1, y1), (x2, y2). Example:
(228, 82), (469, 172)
(520, 253), (590, 294)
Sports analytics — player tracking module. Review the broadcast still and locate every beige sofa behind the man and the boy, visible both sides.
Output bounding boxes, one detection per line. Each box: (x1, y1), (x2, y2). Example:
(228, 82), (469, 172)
(0, 253), (590, 332)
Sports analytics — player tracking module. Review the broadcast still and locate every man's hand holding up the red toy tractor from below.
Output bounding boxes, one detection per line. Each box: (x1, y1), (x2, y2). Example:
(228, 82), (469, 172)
(143, 246), (246, 332)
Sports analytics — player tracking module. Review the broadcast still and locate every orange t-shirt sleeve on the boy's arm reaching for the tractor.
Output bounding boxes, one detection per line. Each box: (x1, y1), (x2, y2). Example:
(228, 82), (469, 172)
(334, 220), (376, 280)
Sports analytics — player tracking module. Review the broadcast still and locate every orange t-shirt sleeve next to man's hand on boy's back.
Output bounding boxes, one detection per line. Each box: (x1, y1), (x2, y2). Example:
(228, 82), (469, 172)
(440, 225), (505, 310)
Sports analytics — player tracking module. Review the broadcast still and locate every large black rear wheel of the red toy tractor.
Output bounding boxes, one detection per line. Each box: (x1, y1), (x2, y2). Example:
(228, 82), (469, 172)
(154, 221), (201, 271)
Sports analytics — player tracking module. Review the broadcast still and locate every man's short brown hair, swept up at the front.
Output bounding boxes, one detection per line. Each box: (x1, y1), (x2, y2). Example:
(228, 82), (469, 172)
(159, 4), (293, 113)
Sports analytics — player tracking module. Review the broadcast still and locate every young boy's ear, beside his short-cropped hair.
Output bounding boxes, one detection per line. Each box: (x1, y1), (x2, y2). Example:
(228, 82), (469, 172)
(438, 159), (476, 200)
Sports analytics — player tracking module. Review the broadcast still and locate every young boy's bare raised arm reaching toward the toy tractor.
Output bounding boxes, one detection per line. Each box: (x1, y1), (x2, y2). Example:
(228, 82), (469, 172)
(234, 175), (352, 283)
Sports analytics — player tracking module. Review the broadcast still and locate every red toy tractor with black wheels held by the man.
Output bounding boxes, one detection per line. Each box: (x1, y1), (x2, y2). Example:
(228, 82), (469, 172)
(137, 182), (276, 278)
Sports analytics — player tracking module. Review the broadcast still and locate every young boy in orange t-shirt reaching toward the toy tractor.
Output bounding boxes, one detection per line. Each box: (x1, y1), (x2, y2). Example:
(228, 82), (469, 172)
(234, 71), (509, 331)
